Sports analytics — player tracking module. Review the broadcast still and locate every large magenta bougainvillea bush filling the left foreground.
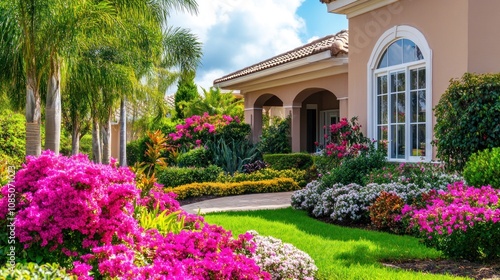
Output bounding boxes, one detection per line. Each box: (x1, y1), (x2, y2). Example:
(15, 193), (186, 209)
(0, 151), (270, 279)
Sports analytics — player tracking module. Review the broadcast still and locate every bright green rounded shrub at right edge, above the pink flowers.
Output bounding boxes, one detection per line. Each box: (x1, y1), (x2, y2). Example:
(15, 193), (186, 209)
(463, 147), (500, 189)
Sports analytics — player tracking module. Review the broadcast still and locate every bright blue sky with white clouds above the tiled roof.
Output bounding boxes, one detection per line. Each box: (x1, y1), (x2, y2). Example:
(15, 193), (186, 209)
(168, 0), (347, 94)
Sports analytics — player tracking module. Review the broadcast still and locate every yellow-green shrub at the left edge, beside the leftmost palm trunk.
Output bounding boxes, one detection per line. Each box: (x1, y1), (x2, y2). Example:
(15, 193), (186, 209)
(0, 110), (26, 166)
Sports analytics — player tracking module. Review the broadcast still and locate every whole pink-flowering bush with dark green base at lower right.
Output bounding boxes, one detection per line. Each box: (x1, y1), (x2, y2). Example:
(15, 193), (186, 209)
(402, 182), (500, 261)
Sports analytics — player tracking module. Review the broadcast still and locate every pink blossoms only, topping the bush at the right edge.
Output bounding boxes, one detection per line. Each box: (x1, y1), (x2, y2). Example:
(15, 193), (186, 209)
(402, 182), (500, 238)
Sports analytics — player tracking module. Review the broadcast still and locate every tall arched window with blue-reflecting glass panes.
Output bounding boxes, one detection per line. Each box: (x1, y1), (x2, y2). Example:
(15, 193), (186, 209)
(369, 28), (432, 161)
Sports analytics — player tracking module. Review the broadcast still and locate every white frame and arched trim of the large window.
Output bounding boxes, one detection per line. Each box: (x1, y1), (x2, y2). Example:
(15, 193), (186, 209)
(367, 25), (433, 162)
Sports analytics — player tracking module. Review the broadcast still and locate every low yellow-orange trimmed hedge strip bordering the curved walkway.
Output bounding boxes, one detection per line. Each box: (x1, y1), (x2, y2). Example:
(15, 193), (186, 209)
(165, 178), (300, 200)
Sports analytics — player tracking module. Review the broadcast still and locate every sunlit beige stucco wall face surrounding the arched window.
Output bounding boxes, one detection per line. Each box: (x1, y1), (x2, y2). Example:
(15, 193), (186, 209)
(348, 0), (474, 160)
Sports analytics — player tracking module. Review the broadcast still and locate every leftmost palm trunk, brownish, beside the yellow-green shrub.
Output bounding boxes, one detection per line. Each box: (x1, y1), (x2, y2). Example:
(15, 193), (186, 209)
(26, 73), (42, 156)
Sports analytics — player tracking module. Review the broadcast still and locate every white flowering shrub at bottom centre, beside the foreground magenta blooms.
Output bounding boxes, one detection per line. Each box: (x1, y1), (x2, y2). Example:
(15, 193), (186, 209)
(248, 230), (318, 280)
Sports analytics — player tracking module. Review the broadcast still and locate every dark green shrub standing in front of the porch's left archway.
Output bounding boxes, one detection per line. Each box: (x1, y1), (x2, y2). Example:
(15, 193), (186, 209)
(257, 117), (292, 154)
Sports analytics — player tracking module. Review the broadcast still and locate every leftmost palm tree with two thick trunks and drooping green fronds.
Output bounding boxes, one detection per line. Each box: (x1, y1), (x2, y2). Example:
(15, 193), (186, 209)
(0, 0), (113, 155)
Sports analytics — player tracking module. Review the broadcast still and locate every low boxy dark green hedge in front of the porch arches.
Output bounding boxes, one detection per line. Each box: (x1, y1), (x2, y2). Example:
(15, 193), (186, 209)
(264, 153), (313, 170)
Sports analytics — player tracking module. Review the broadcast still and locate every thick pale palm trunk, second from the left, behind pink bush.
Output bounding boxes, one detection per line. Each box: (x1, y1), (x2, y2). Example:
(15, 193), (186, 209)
(45, 54), (61, 154)
